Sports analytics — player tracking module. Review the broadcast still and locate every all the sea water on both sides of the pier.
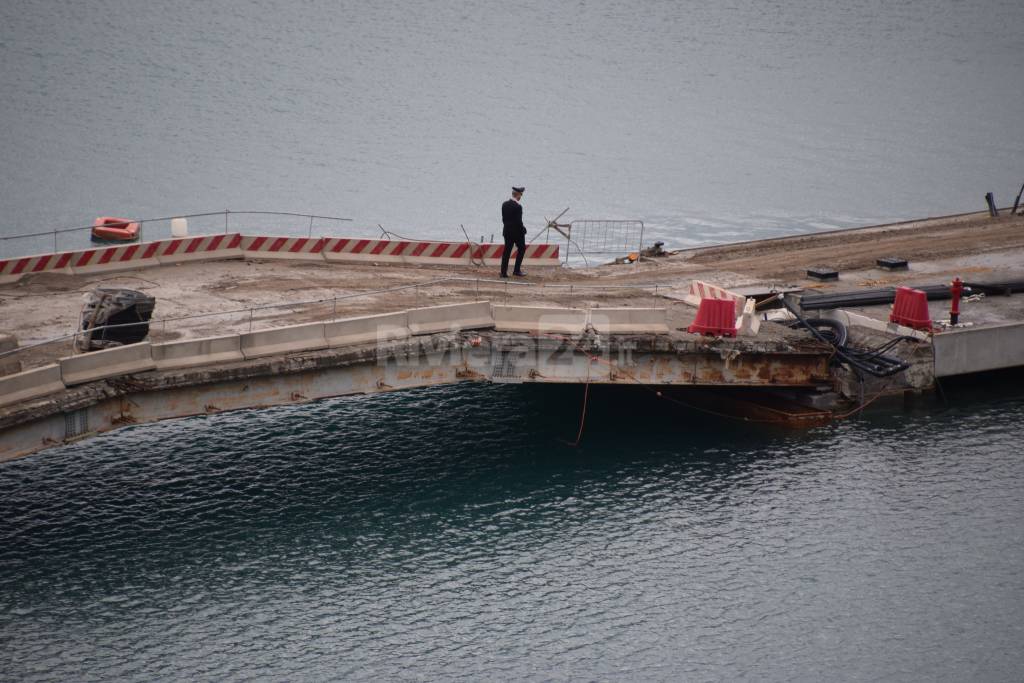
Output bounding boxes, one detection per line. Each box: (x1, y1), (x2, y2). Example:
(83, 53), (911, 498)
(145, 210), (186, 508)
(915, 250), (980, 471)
(0, 0), (1024, 681)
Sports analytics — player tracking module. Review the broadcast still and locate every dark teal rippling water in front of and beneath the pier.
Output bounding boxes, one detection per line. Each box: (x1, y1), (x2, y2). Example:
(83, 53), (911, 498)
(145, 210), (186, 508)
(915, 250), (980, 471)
(0, 386), (1024, 680)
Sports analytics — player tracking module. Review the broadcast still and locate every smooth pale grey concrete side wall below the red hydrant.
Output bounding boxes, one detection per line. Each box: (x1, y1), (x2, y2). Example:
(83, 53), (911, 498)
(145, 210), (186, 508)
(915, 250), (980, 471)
(932, 323), (1024, 377)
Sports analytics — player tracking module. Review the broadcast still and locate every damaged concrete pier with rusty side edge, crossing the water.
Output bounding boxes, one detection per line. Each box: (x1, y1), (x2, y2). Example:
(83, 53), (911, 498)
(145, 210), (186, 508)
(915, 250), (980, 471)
(0, 206), (1024, 460)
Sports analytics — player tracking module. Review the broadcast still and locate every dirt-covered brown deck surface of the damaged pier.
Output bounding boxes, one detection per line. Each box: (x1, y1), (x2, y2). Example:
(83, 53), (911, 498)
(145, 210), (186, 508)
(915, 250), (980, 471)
(0, 212), (1024, 369)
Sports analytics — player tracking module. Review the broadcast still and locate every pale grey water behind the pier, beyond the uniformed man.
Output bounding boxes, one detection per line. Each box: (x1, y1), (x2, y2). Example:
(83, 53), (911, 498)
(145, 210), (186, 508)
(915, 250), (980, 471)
(0, 0), (1024, 254)
